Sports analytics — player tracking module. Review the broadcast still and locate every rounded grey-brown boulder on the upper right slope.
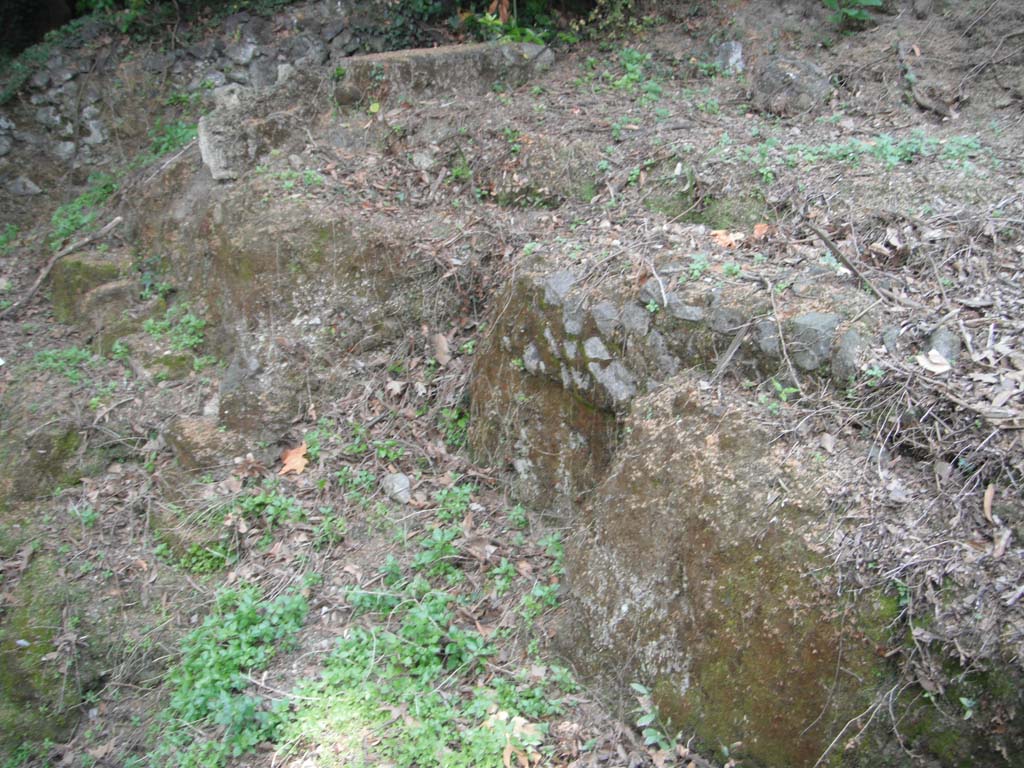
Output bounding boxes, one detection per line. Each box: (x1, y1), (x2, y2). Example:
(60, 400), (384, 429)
(751, 54), (833, 116)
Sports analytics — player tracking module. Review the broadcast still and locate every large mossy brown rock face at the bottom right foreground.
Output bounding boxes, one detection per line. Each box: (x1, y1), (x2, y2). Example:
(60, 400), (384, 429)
(560, 379), (891, 766)
